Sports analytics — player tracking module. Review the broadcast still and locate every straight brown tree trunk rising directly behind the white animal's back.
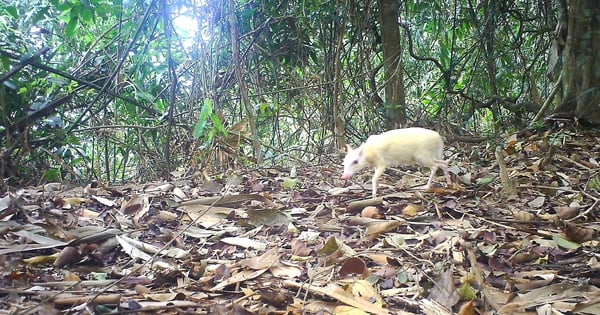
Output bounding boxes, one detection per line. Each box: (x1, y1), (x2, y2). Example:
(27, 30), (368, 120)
(378, 0), (406, 129)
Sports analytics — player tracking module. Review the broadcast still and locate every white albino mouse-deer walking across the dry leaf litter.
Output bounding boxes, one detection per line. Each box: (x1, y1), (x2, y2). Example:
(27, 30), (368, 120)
(342, 128), (452, 198)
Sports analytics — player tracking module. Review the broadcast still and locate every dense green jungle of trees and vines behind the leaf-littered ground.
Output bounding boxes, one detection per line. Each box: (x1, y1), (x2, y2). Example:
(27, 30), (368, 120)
(0, 1), (600, 183)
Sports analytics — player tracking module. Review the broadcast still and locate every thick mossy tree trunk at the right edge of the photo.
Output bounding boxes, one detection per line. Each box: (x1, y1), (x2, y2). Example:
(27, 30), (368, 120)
(555, 0), (600, 124)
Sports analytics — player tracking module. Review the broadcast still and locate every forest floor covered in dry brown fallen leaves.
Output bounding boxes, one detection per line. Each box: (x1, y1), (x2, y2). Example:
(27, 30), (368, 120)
(0, 127), (600, 314)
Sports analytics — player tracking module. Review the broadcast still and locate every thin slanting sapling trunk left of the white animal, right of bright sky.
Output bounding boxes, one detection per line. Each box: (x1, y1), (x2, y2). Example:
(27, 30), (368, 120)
(229, 0), (262, 164)
